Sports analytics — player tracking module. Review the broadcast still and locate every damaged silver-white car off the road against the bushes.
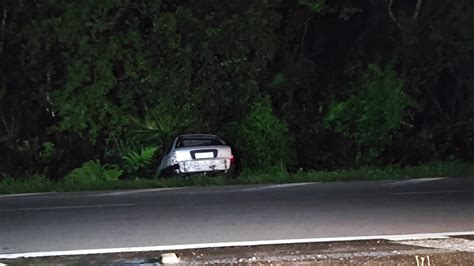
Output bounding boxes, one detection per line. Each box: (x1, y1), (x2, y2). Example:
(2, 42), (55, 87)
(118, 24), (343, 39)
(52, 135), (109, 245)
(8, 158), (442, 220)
(157, 134), (235, 176)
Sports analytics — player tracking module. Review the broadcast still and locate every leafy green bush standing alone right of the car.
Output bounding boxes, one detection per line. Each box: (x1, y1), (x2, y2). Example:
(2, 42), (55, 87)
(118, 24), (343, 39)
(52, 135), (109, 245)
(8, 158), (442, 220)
(326, 65), (411, 162)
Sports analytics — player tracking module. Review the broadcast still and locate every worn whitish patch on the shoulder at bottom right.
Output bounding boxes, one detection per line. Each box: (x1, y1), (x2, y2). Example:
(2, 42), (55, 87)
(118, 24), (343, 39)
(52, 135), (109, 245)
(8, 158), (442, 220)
(397, 238), (474, 252)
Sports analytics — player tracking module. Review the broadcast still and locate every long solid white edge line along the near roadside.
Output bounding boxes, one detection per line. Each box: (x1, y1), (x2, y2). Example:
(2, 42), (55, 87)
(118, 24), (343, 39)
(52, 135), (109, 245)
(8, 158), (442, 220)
(0, 231), (474, 259)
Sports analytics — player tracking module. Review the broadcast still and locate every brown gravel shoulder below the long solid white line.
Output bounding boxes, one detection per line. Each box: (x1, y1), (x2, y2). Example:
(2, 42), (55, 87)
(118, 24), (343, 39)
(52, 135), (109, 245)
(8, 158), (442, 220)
(0, 236), (474, 266)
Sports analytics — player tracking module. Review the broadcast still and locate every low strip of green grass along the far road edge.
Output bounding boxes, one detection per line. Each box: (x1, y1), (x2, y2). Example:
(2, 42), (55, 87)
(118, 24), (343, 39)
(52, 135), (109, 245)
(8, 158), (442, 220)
(0, 162), (474, 194)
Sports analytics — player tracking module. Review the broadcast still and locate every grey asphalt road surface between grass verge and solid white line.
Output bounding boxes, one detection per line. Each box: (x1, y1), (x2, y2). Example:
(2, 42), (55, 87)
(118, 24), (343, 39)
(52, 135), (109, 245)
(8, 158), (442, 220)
(0, 178), (474, 254)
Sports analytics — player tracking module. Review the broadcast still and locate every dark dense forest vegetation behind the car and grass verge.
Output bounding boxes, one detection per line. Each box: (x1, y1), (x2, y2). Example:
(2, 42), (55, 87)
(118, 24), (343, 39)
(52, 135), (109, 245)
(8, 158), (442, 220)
(0, 0), (474, 187)
